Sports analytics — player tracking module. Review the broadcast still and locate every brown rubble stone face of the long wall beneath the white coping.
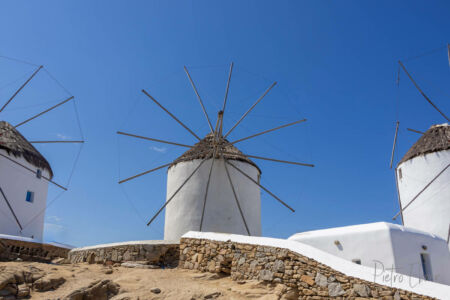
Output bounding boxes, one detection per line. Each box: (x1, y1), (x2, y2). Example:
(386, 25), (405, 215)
(179, 238), (432, 300)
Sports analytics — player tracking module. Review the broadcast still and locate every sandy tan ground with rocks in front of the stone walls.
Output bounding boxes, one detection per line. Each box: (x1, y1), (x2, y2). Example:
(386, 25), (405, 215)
(0, 262), (285, 300)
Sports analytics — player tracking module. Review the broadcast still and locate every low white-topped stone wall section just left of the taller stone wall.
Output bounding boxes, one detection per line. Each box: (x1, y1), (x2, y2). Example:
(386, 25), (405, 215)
(69, 241), (180, 267)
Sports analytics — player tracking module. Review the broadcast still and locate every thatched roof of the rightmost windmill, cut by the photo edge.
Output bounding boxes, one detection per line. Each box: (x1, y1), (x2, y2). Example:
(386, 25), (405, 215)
(399, 124), (450, 164)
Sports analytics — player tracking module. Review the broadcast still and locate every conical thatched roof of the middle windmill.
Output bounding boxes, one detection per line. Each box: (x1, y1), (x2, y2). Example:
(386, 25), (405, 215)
(172, 133), (261, 174)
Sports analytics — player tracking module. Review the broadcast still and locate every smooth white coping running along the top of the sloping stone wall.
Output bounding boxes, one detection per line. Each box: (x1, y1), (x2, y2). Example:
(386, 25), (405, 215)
(183, 231), (450, 299)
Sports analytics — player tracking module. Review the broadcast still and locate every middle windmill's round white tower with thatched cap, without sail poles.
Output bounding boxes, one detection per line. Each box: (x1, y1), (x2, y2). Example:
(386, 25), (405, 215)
(164, 134), (261, 240)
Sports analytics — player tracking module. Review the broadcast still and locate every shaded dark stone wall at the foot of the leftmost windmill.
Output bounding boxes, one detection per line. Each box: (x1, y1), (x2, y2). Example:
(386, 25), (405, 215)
(0, 238), (70, 262)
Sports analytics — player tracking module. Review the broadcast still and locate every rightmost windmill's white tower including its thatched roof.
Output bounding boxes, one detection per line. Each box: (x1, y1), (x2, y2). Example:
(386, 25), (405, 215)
(396, 124), (450, 240)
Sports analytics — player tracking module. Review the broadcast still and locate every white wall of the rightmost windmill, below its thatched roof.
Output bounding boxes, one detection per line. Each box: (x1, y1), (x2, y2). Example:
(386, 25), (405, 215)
(397, 150), (450, 239)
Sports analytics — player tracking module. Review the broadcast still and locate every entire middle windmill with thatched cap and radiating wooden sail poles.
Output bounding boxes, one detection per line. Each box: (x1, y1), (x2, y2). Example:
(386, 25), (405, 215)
(117, 64), (314, 240)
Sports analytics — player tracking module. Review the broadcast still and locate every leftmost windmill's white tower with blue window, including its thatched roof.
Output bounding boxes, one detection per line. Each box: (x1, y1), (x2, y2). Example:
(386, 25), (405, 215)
(0, 121), (53, 241)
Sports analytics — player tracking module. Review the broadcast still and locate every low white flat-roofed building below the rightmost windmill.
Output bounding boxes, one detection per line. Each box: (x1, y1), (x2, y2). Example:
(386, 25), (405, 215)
(289, 222), (450, 285)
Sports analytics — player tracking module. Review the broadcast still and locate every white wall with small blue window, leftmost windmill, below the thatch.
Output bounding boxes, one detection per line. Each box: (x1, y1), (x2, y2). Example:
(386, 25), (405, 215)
(0, 149), (49, 241)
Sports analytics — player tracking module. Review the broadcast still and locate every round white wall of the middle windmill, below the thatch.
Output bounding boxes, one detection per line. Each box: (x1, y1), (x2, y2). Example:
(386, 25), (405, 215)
(164, 159), (261, 240)
